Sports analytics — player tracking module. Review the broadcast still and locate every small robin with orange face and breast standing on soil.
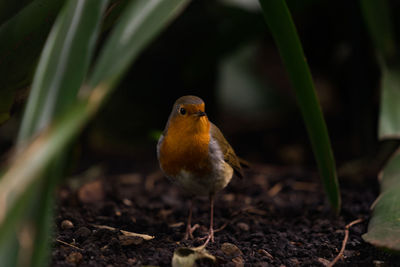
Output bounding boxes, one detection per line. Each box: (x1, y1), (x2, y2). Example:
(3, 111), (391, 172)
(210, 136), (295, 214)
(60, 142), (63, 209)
(157, 96), (243, 245)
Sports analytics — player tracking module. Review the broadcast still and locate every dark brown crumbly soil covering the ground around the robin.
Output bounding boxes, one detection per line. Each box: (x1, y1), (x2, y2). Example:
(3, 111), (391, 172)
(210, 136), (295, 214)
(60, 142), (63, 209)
(52, 162), (400, 266)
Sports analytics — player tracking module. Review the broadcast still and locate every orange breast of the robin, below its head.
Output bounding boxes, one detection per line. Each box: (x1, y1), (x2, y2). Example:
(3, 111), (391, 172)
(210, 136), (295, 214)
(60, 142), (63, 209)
(159, 117), (211, 177)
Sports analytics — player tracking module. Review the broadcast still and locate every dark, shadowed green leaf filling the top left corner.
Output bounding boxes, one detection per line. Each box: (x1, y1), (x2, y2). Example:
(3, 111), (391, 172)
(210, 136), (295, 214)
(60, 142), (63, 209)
(0, 0), (64, 125)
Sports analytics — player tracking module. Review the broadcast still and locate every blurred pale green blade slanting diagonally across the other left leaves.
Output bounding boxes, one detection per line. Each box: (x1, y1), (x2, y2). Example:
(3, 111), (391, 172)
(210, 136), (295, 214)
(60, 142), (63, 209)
(0, 0), (188, 252)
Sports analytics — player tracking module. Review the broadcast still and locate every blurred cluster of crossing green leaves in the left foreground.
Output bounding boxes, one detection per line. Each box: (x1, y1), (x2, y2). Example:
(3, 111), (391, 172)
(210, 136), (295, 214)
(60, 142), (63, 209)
(0, 0), (191, 266)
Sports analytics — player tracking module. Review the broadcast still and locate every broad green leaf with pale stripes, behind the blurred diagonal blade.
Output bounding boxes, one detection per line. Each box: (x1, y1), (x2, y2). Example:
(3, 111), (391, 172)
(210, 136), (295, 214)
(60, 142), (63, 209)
(18, 0), (107, 142)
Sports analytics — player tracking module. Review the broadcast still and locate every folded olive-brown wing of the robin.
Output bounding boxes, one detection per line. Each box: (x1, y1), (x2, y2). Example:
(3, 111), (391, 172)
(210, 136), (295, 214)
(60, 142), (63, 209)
(210, 123), (243, 178)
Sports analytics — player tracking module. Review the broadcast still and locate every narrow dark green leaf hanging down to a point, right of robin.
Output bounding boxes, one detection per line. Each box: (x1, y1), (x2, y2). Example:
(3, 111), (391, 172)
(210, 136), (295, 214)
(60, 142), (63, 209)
(260, 0), (341, 212)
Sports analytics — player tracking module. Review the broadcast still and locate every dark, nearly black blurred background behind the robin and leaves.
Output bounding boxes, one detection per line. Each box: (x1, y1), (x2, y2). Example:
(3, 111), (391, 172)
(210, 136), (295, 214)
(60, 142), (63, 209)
(0, 0), (400, 176)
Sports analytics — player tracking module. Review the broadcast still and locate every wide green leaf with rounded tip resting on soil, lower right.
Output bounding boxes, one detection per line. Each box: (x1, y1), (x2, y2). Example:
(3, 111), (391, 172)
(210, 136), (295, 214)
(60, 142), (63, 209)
(363, 154), (400, 251)
